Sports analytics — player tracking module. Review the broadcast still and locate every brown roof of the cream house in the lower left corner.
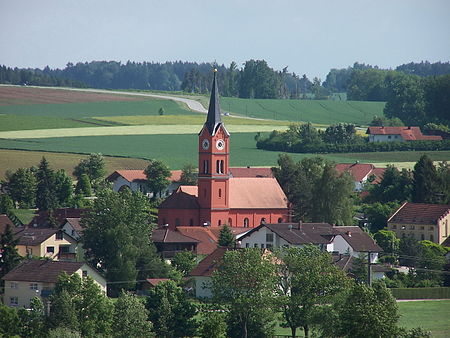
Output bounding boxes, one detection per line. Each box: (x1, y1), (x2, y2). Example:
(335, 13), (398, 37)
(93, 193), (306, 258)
(3, 260), (86, 283)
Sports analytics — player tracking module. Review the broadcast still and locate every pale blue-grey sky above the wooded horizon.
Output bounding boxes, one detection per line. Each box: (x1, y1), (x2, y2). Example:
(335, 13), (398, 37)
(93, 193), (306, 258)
(0, 0), (450, 80)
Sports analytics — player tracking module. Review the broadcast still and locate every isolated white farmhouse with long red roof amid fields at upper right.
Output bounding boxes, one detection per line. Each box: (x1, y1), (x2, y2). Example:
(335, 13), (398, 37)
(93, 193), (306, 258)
(366, 127), (442, 142)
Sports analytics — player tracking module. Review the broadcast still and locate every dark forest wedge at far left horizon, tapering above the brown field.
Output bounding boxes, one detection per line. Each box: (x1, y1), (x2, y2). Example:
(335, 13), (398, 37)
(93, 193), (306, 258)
(0, 66), (87, 88)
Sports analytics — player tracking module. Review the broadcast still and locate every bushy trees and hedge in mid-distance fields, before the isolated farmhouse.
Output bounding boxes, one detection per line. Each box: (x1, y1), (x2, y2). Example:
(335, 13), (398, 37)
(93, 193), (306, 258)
(255, 123), (450, 153)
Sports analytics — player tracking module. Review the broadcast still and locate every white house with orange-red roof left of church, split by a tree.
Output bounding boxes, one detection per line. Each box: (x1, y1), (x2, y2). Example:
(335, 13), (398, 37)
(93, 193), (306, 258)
(106, 169), (182, 196)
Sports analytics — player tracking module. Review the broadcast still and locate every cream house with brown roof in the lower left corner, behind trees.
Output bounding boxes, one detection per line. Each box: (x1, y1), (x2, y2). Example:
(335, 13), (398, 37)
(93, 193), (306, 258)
(2, 260), (106, 308)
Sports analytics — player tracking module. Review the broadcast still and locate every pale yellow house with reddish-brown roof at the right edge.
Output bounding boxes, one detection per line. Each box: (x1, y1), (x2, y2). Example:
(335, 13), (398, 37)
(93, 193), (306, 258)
(387, 202), (450, 244)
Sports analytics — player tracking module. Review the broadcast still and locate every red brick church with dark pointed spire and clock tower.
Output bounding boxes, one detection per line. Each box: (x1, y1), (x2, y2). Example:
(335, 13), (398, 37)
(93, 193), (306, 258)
(158, 70), (290, 230)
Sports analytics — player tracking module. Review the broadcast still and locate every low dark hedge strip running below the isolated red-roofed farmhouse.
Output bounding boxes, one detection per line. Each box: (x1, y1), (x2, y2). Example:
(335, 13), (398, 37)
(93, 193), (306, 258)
(256, 137), (450, 153)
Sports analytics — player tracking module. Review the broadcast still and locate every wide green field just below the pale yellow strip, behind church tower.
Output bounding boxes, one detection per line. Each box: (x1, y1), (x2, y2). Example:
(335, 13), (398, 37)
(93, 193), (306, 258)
(0, 133), (450, 173)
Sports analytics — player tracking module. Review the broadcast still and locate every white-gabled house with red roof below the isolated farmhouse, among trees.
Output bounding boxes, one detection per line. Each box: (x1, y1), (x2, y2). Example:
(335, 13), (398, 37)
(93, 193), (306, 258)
(335, 162), (386, 191)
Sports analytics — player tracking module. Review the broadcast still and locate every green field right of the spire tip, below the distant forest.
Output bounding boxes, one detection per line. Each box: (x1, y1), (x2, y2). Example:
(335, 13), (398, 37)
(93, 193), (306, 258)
(221, 97), (385, 125)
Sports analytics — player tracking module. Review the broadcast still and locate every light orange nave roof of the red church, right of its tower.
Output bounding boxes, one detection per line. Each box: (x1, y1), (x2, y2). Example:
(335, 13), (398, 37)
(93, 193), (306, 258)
(229, 177), (288, 209)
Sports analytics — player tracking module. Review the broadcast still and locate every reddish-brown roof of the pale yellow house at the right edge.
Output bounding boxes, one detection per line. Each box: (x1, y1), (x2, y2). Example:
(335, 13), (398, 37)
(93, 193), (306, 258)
(388, 202), (450, 224)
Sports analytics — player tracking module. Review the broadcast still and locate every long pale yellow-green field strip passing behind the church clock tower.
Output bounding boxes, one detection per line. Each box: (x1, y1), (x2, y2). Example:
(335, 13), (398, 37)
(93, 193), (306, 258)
(0, 125), (286, 139)
